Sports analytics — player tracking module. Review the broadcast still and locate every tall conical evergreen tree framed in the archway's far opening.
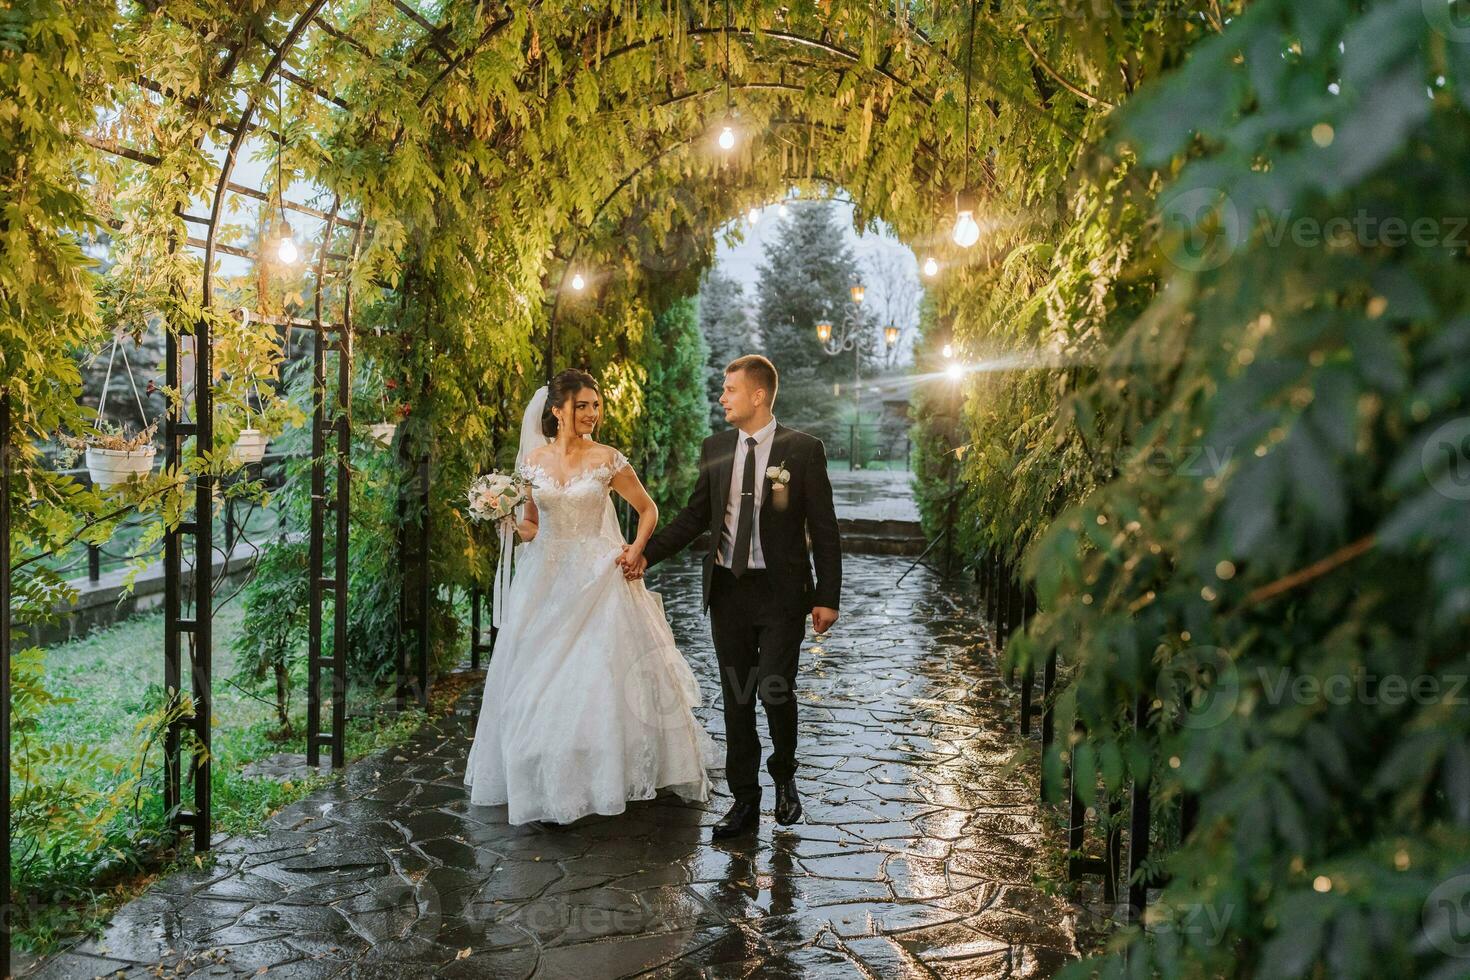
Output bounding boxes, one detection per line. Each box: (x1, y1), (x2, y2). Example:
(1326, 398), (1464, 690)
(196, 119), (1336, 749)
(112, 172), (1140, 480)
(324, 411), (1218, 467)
(757, 201), (870, 441)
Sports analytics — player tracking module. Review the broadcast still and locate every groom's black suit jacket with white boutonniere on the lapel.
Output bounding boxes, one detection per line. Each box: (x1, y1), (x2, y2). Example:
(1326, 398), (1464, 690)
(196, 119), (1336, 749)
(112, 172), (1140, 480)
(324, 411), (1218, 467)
(644, 425), (842, 614)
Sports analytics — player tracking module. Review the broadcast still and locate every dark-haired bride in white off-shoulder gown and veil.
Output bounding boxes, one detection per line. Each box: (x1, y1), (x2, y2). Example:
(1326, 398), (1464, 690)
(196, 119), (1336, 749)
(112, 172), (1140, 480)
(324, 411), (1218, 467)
(465, 370), (714, 824)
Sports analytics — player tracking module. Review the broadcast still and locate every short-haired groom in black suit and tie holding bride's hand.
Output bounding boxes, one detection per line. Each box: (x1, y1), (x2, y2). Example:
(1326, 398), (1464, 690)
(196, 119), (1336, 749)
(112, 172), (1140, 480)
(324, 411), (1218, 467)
(625, 354), (842, 839)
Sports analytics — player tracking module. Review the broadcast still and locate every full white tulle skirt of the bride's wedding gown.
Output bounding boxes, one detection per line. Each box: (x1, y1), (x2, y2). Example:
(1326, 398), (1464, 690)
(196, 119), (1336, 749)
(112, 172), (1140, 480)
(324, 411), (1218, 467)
(465, 536), (716, 824)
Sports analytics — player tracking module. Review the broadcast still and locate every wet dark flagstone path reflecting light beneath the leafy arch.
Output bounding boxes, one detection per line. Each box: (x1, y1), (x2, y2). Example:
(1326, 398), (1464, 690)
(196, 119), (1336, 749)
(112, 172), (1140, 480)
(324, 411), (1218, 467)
(35, 557), (1075, 980)
